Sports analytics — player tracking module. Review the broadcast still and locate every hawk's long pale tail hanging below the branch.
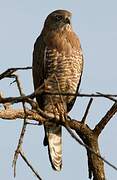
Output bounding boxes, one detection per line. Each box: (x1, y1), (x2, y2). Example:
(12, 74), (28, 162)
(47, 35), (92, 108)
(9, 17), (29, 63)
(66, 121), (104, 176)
(44, 123), (62, 171)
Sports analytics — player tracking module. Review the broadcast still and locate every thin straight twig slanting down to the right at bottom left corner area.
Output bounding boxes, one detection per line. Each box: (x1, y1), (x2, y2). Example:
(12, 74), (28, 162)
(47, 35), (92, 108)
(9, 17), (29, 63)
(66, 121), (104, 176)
(19, 150), (42, 180)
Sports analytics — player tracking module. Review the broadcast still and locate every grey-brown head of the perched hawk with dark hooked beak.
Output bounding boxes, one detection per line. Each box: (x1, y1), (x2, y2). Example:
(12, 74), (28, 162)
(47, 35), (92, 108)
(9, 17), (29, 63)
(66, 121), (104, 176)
(44, 10), (71, 30)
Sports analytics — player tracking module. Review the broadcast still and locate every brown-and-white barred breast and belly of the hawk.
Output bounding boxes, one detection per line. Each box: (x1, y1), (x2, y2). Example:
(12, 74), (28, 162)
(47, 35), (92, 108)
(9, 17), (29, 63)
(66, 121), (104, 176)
(45, 48), (83, 98)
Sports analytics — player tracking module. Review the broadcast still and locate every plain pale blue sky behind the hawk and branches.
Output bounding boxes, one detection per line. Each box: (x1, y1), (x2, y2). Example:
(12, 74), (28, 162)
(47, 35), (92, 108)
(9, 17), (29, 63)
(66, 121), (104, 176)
(0, 0), (117, 180)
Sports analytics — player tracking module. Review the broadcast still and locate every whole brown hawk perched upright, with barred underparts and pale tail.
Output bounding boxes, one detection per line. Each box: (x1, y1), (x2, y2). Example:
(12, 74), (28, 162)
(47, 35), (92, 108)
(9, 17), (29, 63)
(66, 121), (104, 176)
(33, 10), (83, 171)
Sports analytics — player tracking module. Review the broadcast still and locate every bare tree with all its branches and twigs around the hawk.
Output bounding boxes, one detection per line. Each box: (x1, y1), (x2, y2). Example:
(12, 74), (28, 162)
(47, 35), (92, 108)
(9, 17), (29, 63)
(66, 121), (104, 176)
(0, 67), (117, 180)
